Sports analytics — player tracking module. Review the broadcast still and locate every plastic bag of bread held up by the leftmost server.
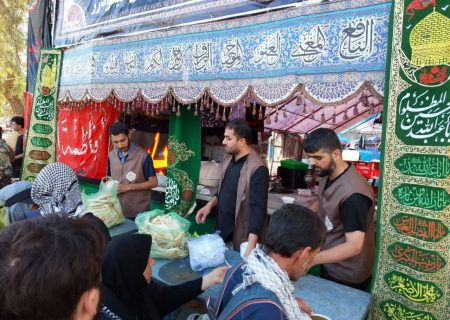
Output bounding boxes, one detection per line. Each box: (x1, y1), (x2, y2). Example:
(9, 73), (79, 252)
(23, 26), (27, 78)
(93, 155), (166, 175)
(82, 177), (125, 228)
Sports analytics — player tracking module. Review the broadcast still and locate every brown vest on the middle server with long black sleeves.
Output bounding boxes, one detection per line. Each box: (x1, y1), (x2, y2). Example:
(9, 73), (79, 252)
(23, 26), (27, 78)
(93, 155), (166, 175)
(219, 150), (269, 251)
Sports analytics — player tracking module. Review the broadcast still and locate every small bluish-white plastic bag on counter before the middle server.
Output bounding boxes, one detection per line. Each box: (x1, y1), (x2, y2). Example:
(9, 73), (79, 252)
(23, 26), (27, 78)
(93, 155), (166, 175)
(188, 234), (226, 271)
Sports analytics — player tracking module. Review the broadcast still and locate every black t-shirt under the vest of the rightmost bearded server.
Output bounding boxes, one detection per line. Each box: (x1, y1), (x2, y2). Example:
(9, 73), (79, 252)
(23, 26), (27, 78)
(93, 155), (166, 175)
(325, 166), (372, 232)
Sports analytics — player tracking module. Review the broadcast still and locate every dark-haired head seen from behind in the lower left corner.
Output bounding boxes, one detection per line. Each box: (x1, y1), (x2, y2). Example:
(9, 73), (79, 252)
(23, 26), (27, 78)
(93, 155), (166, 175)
(0, 214), (105, 320)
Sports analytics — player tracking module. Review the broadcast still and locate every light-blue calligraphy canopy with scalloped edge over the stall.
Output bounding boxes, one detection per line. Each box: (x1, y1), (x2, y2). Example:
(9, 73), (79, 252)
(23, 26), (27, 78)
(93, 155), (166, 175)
(59, 0), (390, 109)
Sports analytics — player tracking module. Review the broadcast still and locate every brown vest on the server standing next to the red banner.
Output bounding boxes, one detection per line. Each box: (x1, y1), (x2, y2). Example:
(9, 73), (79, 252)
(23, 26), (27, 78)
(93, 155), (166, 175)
(109, 146), (152, 218)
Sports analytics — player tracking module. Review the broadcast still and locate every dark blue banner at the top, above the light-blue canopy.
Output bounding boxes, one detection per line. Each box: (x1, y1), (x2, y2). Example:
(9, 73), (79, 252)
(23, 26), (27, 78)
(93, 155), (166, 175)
(55, 0), (297, 47)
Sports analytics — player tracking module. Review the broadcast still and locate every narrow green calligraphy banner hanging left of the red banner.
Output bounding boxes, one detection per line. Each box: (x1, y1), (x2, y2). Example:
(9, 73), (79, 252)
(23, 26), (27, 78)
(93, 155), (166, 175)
(22, 49), (62, 181)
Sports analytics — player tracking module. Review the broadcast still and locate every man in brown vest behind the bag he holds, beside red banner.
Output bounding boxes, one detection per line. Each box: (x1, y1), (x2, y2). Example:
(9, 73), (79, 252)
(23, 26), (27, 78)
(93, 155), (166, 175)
(108, 122), (158, 218)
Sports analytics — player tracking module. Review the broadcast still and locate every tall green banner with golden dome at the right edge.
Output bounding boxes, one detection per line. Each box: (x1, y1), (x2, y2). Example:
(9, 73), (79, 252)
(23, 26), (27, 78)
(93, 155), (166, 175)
(369, 0), (450, 320)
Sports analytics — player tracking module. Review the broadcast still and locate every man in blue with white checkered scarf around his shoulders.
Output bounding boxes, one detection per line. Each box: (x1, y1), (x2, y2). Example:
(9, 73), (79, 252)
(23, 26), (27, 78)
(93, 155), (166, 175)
(208, 204), (327, 320)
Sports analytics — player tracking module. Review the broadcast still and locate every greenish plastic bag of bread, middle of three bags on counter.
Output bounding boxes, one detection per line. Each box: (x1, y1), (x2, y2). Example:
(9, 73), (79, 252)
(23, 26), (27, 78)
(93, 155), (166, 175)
(135, 209), (191, 259)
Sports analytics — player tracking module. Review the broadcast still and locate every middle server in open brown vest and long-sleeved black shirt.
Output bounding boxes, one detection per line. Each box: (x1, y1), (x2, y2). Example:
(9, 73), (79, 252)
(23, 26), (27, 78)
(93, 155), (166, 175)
(195, 119), (269, 256)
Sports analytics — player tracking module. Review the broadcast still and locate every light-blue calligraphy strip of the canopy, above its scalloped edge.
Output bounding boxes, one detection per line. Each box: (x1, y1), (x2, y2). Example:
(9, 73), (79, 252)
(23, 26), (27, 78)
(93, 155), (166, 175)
(61, 0), (391, 99)
